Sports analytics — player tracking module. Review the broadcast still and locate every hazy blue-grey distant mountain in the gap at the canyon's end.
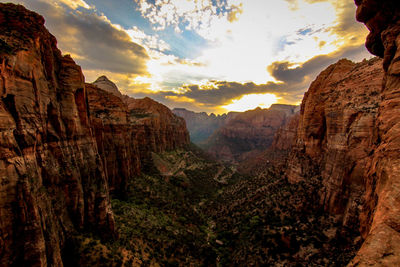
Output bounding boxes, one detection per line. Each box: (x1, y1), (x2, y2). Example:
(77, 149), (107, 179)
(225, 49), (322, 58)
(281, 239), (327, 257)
(172, 108), (238, 145)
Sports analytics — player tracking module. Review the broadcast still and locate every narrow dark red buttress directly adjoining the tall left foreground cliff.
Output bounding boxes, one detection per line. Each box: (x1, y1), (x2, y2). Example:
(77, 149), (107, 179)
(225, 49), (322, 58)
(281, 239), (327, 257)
(86, 84), (141, 196)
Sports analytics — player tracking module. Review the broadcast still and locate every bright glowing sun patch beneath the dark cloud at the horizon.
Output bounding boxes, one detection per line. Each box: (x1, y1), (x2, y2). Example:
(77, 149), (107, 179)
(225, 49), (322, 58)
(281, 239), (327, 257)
(221, 93), (278, 112)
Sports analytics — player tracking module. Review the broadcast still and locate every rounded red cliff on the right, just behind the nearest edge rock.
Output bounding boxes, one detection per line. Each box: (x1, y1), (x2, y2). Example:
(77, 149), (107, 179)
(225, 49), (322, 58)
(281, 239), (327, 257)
(286, 58), (383, 233)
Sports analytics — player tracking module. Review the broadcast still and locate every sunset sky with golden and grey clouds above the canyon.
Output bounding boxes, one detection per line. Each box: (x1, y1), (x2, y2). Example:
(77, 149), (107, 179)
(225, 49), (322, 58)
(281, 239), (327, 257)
(10, 0), (371, 114)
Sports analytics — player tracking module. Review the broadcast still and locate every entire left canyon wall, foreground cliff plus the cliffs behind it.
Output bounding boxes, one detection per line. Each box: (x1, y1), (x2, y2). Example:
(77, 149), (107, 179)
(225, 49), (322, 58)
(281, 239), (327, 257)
(0, 4), (189, 266)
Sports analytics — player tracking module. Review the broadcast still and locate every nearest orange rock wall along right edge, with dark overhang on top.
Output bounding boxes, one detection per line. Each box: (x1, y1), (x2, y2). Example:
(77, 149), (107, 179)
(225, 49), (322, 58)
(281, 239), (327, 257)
(351, 0), (400, 266)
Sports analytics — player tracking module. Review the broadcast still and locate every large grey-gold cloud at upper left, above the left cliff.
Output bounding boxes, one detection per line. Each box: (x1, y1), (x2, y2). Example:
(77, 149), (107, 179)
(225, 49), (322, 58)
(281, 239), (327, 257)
(9, 0), (149, 75)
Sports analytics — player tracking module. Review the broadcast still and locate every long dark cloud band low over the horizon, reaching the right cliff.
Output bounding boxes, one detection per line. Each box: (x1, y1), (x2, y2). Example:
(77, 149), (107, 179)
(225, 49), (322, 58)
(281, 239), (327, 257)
(133, 45), (370, 112)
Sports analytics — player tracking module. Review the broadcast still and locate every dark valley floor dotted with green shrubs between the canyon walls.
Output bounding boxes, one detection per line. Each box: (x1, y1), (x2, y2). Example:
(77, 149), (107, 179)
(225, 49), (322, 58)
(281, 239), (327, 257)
(68, 147), (357, 266)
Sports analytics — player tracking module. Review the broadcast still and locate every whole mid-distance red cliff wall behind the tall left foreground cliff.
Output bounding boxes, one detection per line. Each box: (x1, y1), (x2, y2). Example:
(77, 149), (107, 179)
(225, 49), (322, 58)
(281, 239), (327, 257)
(86, 87), (190, 195)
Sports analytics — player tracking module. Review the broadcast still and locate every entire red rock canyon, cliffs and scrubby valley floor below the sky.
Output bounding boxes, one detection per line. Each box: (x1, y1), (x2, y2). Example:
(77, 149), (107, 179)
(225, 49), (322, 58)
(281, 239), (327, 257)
(0, 0), (400, 266)
